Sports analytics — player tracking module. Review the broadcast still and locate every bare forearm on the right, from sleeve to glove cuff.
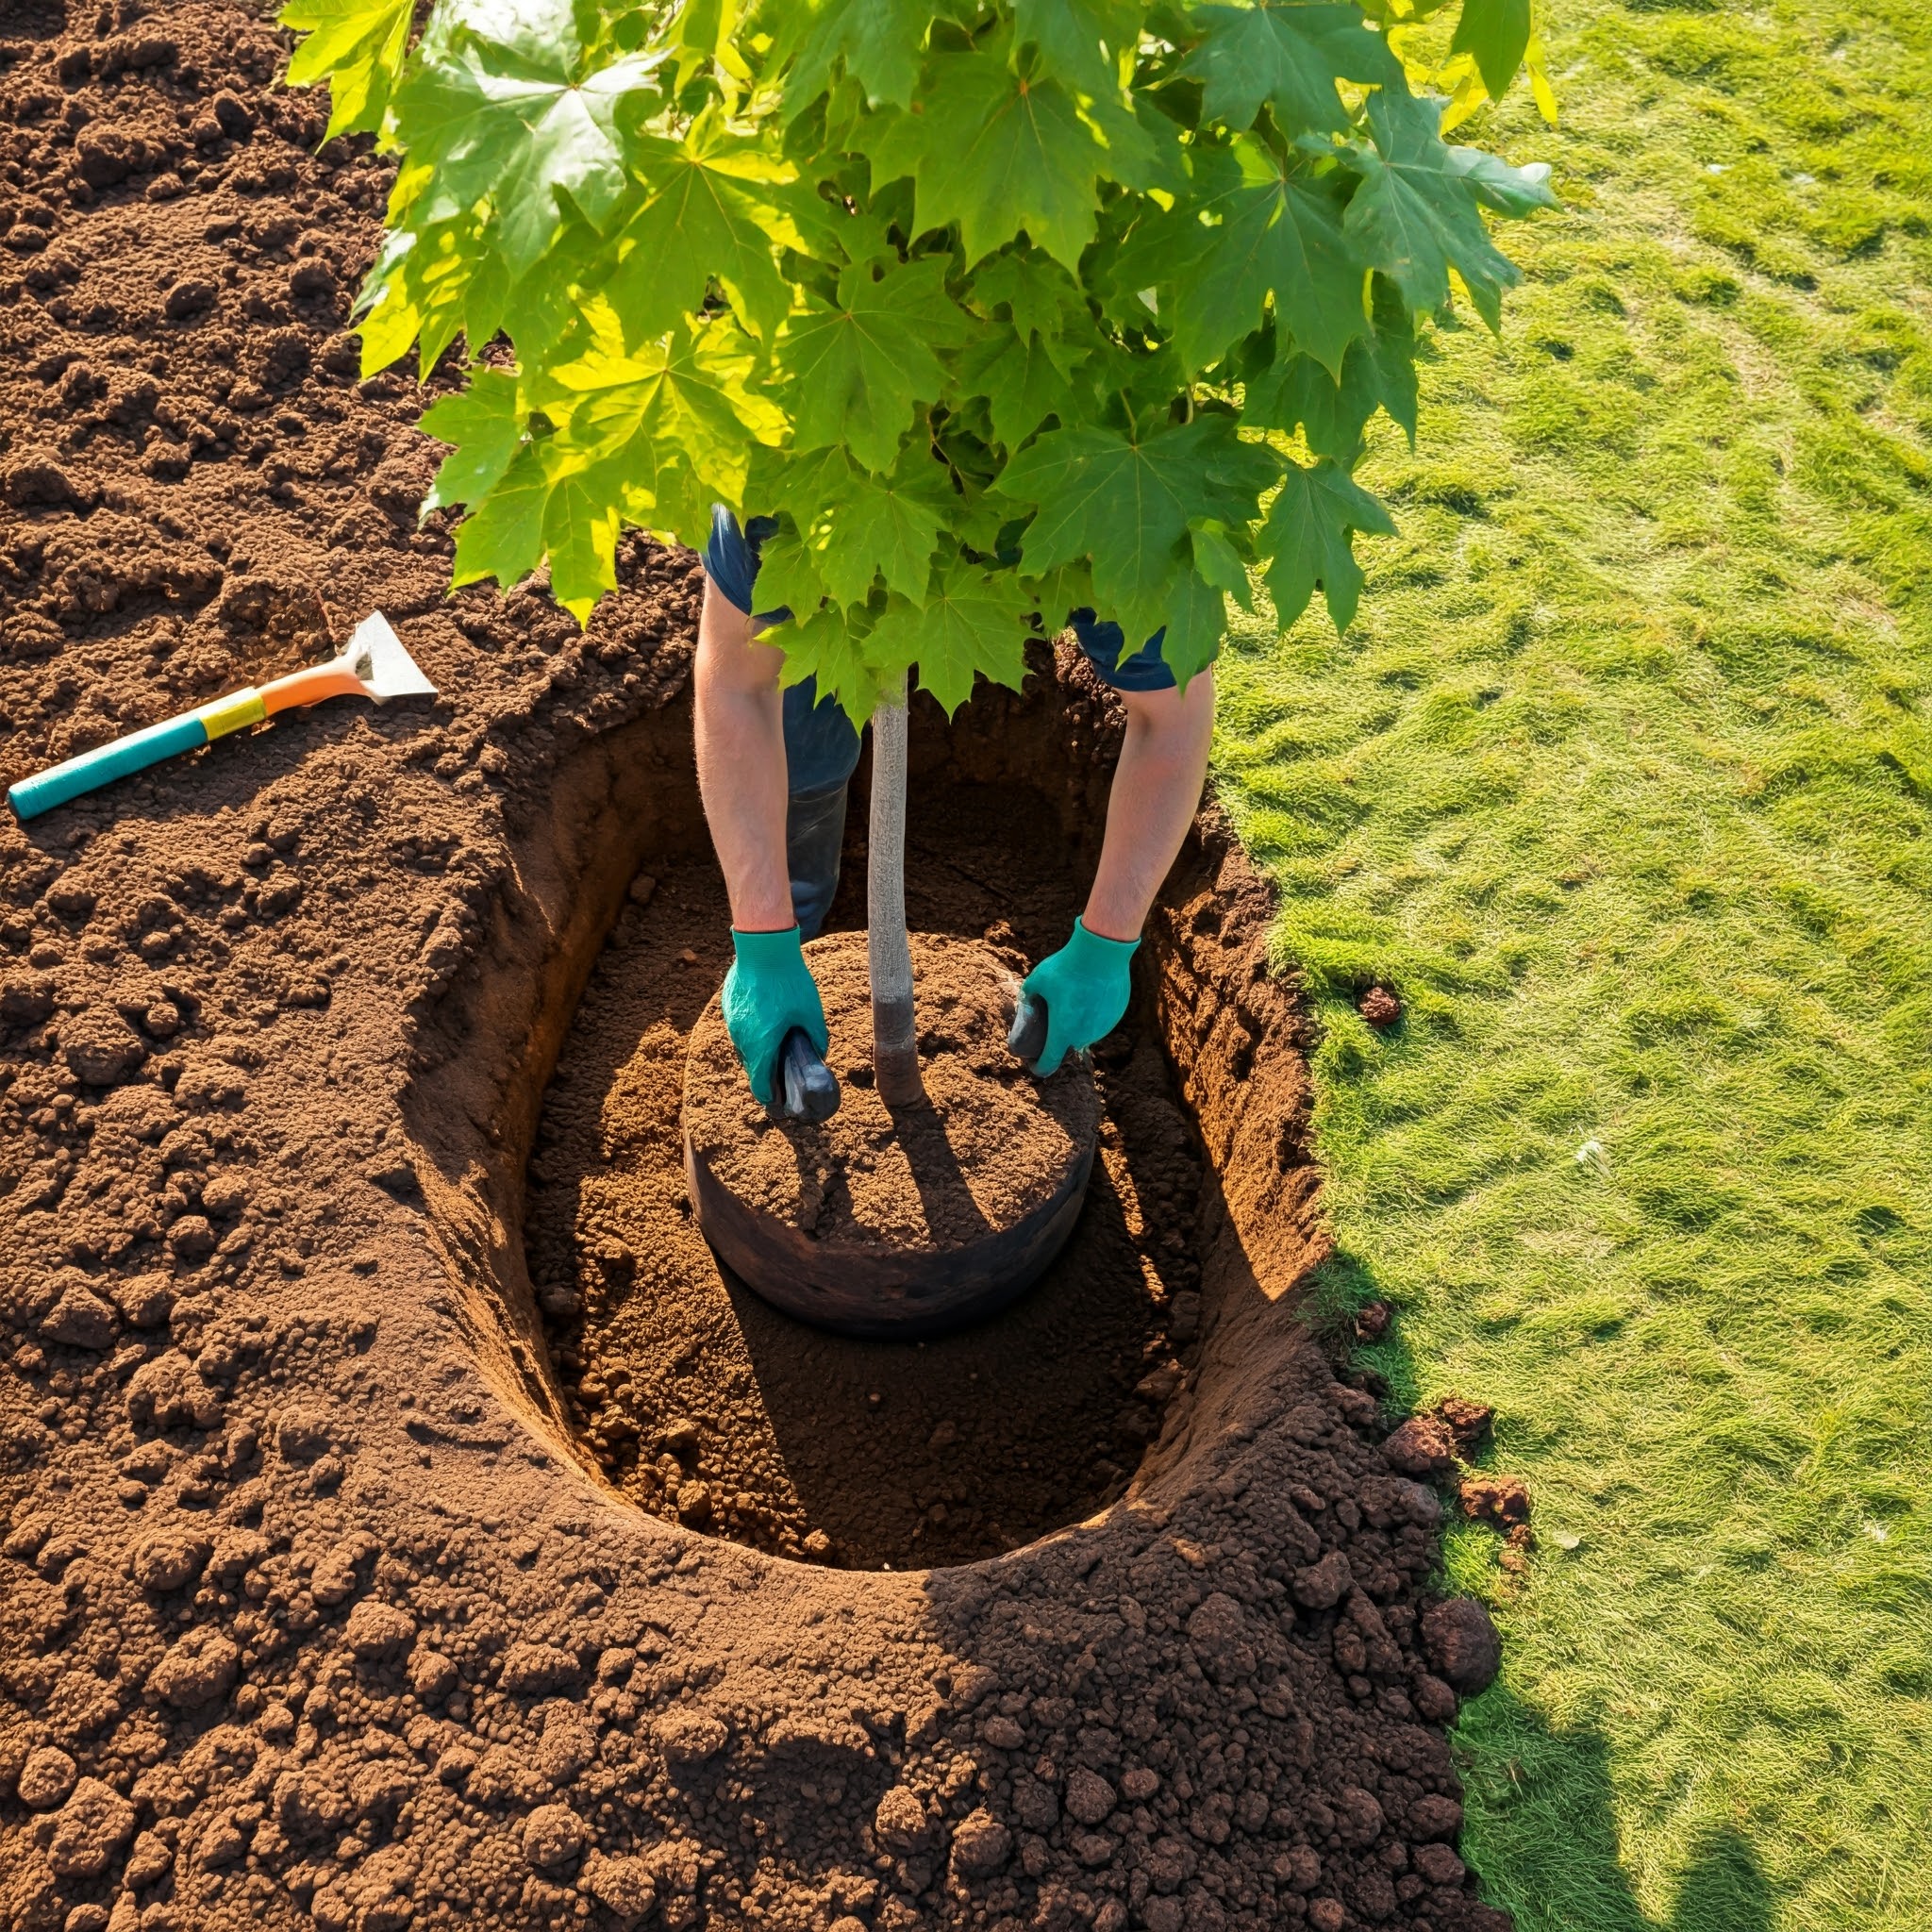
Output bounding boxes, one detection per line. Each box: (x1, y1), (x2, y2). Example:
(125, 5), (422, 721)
(1080, 671), (1213, 939)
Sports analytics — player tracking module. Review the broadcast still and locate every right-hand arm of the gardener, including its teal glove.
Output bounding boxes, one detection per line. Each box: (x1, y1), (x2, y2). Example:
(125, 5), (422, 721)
(1012, 671), (1213, 1074)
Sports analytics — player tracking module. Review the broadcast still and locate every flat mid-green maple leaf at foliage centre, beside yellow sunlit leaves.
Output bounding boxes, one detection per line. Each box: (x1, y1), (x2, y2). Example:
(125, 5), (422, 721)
(780, 258), (966, 470)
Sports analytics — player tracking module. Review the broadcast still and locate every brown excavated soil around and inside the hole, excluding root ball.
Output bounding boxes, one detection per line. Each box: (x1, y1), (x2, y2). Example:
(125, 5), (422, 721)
(0, 0), (1507, 1932)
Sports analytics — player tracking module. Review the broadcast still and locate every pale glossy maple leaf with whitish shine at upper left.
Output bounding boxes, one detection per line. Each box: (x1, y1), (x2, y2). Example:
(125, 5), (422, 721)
(396, 41), (660, 276)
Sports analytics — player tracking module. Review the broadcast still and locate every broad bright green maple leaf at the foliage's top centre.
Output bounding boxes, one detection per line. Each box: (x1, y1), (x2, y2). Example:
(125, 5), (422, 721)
(874, 48), (1148, 271)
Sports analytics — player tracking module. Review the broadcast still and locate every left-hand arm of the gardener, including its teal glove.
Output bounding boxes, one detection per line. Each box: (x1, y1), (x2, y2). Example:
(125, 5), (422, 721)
(693, 581), (829, 1108)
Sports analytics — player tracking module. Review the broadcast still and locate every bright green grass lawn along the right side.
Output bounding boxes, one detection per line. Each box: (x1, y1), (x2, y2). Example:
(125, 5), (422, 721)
(1217, 0), (1932, 1932)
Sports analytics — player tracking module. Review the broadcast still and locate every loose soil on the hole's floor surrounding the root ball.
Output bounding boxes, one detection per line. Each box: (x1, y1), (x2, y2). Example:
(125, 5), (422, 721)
(527, 769), (1200, 1569)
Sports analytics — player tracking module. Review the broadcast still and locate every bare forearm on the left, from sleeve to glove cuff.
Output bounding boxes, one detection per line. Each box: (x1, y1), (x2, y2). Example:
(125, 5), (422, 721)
(693, 583), (796, 933)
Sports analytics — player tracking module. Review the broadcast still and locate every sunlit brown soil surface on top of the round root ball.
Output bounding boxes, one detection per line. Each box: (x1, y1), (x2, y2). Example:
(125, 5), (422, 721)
(684, 933), (1099, 1256)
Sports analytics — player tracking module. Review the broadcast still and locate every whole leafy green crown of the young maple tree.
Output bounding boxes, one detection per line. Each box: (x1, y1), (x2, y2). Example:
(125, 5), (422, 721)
(282, 0), (1554, 1112)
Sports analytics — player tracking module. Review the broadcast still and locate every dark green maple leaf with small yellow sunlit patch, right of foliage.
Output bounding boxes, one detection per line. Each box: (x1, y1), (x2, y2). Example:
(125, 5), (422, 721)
(1154, 135), (1368, 369)
